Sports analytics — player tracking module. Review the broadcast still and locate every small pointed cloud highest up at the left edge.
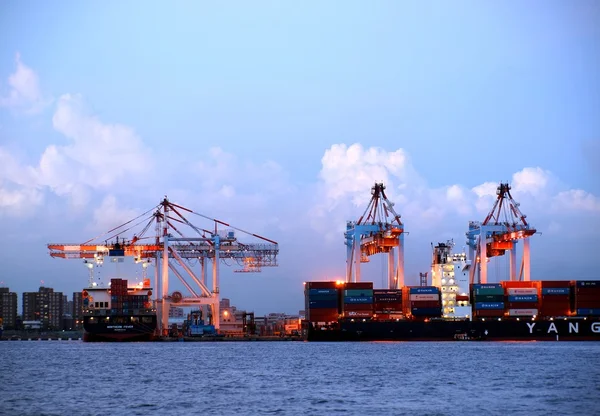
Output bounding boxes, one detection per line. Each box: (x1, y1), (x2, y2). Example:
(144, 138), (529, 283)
(0, 53), (52, 114)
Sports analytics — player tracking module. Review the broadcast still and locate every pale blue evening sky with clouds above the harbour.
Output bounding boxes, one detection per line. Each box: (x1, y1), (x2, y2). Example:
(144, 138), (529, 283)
(0, 0), (600, 314)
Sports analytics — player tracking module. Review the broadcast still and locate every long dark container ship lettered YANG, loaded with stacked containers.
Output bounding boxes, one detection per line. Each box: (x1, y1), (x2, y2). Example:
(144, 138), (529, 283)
(303, 280), (600, 341)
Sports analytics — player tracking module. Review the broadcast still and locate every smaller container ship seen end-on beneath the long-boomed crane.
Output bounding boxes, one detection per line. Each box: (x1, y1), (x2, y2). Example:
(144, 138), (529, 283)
(82, 279), (157, 342)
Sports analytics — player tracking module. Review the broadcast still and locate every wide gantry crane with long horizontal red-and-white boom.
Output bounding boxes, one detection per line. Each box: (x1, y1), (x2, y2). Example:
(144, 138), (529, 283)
(48, 197), (279, 333)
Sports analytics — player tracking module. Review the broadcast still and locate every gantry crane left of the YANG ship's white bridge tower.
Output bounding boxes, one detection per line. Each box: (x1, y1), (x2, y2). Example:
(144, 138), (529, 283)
(344, 183), (404, 289)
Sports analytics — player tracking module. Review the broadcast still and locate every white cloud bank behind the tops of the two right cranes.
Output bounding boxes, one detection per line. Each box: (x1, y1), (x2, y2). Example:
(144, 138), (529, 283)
(310, 144), (600, 241)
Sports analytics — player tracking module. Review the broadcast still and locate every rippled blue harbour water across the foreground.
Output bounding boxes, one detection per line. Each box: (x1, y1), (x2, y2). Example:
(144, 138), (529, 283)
(0, 341), (600, 416)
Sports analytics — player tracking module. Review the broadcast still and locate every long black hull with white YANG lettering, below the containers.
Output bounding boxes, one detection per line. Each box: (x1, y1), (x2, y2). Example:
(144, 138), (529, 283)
(306, 319), (600, 341)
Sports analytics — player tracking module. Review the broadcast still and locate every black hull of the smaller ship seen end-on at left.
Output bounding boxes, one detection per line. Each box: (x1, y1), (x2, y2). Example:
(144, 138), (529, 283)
(83, 315), (157, 342)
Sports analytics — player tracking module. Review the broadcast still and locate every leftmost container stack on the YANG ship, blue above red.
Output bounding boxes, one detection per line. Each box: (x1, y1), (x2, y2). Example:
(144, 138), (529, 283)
(304, 282), (339, 322)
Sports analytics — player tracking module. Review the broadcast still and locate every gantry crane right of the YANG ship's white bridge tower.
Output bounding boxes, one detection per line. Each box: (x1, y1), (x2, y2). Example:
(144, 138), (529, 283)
(466, 183), (536, 283)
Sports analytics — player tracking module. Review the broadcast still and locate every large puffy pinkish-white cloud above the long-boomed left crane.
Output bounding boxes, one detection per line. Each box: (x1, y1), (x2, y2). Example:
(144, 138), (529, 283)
(0, 94), (153, 214)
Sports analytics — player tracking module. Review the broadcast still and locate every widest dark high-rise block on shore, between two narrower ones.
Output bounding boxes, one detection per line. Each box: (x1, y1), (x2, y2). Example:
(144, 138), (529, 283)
(23, 286), (64, 330)
